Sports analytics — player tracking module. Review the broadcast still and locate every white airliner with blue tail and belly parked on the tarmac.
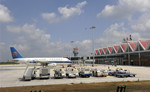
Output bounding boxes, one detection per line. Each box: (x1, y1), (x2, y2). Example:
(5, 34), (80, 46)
(10, 47), (72, 66)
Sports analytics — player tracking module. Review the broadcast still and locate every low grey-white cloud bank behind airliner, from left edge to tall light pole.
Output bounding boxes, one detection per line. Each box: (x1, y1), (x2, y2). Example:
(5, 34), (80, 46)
(0, 24), (92, 62)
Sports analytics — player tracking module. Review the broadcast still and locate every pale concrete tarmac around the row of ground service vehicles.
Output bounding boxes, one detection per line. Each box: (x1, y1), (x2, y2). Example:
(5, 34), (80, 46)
(0, 64), (150, 88)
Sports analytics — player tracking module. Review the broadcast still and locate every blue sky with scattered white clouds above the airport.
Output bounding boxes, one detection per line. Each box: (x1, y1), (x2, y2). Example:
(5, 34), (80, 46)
(0, 0), (150, 62)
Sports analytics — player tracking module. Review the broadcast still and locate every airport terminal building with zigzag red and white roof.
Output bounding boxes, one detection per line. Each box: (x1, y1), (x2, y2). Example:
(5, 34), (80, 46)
(95, 40), (150, 66)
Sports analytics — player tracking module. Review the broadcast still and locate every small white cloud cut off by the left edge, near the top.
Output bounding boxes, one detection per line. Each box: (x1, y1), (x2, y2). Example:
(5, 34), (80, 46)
(0, 4), (13, 23)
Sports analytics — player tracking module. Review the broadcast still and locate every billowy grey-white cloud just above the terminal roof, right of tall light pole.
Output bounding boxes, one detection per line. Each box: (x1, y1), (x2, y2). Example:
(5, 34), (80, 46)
(95, 23), (141, 48)
